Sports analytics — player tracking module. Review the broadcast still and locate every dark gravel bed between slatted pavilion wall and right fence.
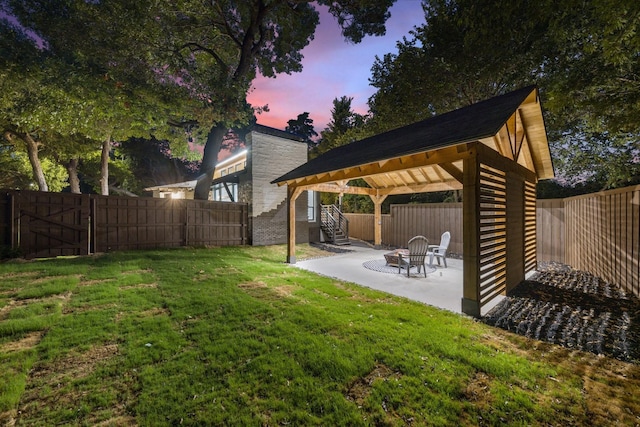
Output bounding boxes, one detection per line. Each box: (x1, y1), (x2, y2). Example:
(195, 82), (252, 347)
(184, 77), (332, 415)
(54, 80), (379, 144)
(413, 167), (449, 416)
(483, 263), (640, 363)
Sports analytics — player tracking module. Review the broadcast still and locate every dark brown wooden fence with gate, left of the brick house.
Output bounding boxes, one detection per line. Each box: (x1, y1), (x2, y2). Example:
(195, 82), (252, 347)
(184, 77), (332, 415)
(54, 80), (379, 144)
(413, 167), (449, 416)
(0, 191), (248, 258)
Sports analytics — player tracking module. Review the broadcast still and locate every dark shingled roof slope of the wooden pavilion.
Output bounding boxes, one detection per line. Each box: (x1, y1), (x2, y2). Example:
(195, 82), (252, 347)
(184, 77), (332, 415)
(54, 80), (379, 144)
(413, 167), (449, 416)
(272, 86), (536, 184)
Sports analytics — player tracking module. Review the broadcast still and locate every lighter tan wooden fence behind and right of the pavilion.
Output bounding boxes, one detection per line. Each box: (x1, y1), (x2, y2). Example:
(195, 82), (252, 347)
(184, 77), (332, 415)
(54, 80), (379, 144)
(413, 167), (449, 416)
(345, 186), (640, 296)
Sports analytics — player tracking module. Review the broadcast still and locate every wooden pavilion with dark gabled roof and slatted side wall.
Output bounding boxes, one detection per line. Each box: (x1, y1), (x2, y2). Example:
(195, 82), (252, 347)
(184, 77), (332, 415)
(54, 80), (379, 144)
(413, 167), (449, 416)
(273, 86), (554, 317)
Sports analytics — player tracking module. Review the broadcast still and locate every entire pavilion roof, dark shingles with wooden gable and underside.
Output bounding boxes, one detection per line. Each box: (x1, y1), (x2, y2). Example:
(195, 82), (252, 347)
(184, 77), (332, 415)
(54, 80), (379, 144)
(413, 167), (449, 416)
(272, 86), (553, 192)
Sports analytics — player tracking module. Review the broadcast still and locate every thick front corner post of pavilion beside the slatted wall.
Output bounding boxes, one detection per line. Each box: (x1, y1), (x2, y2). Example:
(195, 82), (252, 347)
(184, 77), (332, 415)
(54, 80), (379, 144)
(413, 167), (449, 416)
(462, 149), (480, 317)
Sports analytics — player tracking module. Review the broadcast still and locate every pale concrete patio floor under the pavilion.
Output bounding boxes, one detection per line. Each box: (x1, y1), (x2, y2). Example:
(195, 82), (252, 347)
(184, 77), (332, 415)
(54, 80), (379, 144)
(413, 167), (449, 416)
(294, 240), (502, 315)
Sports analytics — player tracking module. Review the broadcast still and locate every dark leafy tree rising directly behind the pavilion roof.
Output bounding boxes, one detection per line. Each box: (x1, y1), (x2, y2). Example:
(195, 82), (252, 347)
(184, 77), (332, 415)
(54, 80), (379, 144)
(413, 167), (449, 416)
(369, 0), (546, 132)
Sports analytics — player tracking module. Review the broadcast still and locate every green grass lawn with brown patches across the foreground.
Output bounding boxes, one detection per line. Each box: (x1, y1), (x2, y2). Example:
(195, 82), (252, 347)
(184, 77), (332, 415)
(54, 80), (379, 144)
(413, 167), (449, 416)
(0, 245), (640, 426)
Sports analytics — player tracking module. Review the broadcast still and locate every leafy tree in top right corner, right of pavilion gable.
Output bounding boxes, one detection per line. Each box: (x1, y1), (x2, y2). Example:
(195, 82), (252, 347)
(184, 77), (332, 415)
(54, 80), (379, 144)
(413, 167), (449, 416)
(544, 0), (640, 189)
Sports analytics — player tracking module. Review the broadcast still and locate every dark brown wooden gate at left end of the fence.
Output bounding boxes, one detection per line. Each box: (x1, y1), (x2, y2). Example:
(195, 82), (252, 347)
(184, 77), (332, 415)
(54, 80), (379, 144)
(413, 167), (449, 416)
(7, 191), (91, 258)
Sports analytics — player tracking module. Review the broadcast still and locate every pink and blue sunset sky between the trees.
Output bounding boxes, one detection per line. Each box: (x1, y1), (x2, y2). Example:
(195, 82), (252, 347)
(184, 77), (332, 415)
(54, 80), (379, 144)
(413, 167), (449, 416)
(248, 0), (424, 134)
